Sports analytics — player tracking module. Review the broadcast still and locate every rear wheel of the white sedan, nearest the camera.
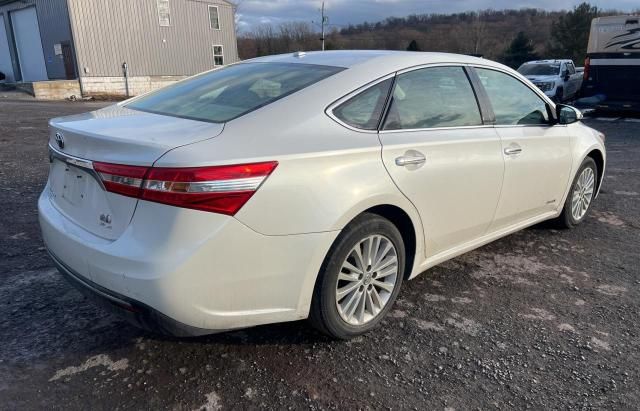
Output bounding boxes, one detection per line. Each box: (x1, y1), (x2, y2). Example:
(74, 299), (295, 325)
(309, 213), (406, 340)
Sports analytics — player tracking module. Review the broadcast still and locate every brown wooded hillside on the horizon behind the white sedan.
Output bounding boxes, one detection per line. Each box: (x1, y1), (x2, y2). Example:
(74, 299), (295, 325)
(238, 3), (632, 65)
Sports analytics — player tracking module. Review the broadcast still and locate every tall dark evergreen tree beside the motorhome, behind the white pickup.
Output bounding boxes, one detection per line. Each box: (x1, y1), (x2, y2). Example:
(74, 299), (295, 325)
(548, 3), (598, 62)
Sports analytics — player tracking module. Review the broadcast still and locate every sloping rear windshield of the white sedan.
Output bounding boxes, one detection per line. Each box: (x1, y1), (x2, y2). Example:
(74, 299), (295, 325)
(126, 63), (344, 123)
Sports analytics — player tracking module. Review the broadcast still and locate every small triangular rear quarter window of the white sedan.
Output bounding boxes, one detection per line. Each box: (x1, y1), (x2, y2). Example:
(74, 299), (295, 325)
(333, 79), (393, 130)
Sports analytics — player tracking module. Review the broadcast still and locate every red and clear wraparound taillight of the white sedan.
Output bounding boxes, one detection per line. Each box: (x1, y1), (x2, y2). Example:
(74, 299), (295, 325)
(94, 161), (278, 215)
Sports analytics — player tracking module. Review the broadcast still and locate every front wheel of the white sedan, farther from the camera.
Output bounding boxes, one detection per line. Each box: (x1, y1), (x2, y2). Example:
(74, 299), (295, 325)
(555, 157), (598, 228)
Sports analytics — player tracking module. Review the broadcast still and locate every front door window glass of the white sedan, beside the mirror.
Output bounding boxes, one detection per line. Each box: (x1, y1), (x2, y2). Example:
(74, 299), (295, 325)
(476, 68), (549, 126)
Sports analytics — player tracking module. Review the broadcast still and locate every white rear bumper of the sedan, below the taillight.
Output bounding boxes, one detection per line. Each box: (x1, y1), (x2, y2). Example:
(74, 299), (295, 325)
(38, 188), (338, 336)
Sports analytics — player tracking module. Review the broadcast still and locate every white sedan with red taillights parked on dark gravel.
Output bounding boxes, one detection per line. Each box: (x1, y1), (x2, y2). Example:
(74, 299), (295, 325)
(38, 51), (606, 338)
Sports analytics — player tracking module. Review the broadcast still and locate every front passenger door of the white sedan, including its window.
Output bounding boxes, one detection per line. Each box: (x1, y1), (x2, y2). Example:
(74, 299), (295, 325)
(475, 67), (572, 231)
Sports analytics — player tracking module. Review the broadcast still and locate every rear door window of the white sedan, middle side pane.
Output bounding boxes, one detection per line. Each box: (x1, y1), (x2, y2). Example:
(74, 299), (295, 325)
(383, 67), (482, 130)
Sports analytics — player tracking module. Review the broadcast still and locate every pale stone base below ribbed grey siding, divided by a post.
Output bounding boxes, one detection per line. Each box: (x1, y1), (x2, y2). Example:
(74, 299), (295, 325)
(80, 76), (186, 96)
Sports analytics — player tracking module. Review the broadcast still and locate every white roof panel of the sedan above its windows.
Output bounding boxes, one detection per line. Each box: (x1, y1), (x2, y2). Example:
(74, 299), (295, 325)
(246, 50), (496, 70)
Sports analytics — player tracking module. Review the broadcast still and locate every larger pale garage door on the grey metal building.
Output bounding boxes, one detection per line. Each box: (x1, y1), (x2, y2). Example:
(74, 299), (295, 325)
(10, 7), (47, 81)
